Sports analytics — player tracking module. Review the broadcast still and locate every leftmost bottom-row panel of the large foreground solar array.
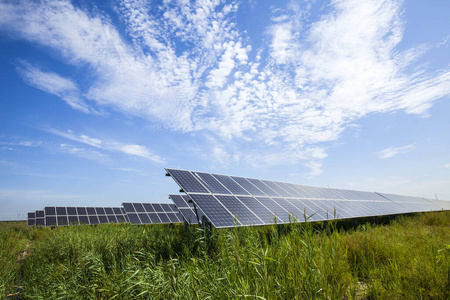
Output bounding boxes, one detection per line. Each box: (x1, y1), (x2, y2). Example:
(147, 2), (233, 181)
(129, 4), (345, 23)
(190, 194), (235, 228)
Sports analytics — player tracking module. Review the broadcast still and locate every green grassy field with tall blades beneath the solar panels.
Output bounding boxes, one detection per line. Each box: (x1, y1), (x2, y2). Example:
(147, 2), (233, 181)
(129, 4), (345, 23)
(0, 211), (450, 299)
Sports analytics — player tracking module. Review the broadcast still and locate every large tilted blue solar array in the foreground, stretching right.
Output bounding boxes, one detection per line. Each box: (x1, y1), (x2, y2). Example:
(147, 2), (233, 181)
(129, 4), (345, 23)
(166, 169), (448, 228)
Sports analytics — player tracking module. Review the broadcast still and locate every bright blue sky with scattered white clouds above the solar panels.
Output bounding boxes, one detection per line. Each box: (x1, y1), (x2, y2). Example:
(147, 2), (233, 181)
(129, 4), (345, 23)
(0, 0), (450, 220)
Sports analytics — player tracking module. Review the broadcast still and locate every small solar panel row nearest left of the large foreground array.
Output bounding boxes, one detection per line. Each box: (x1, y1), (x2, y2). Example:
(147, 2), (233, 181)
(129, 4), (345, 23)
(122, 203), (183, 224)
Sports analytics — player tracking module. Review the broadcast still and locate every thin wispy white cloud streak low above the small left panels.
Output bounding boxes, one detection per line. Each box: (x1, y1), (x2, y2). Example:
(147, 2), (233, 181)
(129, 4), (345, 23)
(47, 128), (164, 163)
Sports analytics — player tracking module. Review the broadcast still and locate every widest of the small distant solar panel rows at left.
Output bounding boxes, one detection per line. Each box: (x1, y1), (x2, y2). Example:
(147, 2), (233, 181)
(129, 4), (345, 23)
(42, 206), (128, 226)
